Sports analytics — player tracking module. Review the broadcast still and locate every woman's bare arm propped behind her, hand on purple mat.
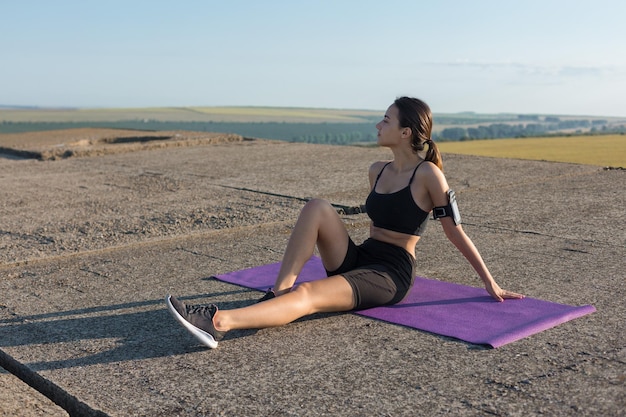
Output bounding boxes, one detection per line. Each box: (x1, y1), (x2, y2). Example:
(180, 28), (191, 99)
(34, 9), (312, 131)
(425, 164), (524, 301)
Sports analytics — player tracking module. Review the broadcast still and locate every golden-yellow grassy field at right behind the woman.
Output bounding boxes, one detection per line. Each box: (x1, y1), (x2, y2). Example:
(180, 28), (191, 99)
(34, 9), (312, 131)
(438, 135), (626, 168)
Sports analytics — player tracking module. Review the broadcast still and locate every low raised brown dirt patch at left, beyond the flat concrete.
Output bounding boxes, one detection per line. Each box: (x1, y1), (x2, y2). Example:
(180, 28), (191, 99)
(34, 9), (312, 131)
(0, 128), (246, 161)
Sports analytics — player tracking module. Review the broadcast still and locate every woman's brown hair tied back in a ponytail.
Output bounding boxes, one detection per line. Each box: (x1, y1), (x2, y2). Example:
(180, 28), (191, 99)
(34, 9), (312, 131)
(393, 97), (443, 171)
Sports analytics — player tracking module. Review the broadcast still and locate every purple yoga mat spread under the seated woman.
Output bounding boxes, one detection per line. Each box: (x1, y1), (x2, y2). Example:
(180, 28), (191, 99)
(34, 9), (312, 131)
(215, 256), (596, 348)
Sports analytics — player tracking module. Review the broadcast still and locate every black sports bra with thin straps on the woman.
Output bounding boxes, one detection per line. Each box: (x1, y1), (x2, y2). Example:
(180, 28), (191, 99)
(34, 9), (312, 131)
(365, 161), (428, 236)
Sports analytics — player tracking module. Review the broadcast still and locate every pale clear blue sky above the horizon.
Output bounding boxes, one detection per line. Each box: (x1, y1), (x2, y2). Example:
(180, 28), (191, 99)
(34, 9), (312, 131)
(0, 0), (626, 116)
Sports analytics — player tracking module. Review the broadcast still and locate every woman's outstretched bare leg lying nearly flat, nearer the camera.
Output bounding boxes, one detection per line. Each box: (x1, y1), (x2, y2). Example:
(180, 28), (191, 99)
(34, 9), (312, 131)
(213, 275), (354, 331)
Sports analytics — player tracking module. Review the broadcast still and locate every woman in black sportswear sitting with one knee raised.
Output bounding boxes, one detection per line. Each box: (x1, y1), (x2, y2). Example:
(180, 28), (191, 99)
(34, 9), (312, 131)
(166, 97), (523, 348)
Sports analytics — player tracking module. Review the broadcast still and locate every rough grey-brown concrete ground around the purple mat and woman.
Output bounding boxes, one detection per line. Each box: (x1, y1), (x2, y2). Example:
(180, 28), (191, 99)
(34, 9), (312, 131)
(0, 135), (626, 416)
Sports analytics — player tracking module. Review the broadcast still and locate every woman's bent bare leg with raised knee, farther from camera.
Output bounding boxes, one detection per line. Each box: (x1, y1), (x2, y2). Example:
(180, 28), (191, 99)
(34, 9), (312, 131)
(274, 199), (349, 295)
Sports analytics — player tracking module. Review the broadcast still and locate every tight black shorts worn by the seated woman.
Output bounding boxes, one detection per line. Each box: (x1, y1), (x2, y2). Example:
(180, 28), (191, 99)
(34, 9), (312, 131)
(326, 238), (415, 310)
